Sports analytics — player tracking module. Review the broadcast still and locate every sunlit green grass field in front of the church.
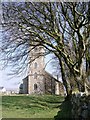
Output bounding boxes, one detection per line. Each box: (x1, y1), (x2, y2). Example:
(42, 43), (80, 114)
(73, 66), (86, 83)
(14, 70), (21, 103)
(2, 95), (64, 118)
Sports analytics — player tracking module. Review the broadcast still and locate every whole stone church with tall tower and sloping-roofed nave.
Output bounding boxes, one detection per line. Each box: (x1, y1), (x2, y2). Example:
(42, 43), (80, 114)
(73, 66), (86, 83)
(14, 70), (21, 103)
(20, 46), (64, 95)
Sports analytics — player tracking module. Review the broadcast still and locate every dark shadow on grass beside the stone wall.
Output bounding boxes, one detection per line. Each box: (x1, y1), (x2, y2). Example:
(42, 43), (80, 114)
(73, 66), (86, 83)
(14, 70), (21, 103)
(54, 100), (72, 120)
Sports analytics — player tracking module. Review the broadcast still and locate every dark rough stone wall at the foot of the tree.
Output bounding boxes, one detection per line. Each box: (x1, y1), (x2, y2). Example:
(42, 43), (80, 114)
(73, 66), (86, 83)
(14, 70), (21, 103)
(71, 93), (90, 120)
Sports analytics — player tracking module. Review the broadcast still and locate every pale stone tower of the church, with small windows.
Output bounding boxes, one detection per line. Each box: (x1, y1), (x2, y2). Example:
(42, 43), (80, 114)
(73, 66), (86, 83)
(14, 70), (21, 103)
(28, 46), (45, 94)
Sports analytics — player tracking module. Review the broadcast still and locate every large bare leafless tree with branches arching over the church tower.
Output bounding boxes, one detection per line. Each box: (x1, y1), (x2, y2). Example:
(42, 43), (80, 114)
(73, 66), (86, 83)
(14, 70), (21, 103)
(2, 2), (90, 97)
